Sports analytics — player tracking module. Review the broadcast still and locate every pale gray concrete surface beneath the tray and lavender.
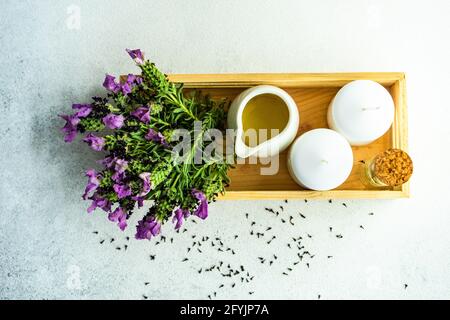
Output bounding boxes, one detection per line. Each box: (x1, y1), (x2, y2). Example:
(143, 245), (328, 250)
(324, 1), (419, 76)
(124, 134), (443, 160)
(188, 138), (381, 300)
(0, 0), (450, 299)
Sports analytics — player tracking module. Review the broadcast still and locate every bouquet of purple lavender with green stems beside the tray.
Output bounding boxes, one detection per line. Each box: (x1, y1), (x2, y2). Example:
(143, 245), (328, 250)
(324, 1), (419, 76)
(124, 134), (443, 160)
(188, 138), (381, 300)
(61, 49), (230, 240)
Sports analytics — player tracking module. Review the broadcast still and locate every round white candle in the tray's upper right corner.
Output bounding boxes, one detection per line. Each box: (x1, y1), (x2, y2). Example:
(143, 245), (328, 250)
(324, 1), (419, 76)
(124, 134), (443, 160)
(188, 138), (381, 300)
(328, 80), (394, 146)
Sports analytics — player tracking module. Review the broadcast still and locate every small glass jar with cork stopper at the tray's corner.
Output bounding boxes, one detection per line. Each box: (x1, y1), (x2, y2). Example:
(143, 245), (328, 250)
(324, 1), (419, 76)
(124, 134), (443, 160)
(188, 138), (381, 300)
(361, 149), (413, 188)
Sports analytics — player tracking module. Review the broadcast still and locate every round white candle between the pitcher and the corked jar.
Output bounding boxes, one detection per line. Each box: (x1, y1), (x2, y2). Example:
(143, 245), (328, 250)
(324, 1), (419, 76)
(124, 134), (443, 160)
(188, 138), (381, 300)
(288, 129), (353, 191)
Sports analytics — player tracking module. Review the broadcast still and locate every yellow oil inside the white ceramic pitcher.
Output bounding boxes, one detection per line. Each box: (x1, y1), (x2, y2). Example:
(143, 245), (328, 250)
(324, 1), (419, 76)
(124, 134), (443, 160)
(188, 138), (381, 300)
(242, 94), (289, 147)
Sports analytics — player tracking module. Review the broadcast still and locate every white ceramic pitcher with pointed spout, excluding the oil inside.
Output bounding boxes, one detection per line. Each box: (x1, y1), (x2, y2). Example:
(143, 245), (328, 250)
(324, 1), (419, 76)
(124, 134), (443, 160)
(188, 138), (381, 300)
(228, 85), (300, 158)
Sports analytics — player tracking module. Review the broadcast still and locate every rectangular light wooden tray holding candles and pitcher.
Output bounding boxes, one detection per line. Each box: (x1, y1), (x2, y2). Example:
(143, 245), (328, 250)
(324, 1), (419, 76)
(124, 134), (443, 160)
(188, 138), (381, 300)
(169, 73), (409, 199)
